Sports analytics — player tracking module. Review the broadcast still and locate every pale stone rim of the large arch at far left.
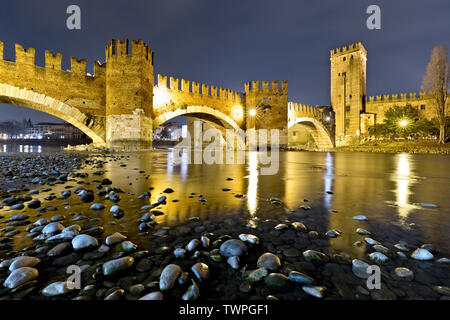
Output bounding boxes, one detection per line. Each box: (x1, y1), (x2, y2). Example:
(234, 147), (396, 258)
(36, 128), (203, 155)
(0, 83), (105, 145)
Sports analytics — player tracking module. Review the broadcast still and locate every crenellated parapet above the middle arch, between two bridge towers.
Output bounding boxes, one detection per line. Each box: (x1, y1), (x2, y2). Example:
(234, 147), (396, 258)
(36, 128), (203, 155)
(155, 74), (243, 103)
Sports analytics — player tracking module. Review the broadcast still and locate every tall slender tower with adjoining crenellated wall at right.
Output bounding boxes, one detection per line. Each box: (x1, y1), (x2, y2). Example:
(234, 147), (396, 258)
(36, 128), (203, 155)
(330, 42), (450, 146)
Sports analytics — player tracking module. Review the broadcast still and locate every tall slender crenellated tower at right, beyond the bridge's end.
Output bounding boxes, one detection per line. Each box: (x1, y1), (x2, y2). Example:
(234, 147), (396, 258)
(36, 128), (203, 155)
(330, 42), (367, 146)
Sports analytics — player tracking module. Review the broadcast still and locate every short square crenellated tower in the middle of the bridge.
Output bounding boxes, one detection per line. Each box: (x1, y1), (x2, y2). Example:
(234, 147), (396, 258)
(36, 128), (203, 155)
(245, 81), (288, 147)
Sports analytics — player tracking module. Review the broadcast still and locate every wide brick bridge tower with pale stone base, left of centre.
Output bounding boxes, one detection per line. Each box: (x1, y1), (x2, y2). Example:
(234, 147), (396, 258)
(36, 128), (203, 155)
(106, 39), (154, 149)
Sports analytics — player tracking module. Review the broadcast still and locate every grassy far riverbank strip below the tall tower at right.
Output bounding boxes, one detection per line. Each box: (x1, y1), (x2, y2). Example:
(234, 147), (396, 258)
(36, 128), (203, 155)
(335, 141), (450, 154)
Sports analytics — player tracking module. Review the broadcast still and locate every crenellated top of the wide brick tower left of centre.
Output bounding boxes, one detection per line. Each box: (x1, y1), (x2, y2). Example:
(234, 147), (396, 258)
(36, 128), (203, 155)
(105, 39), (153, 65)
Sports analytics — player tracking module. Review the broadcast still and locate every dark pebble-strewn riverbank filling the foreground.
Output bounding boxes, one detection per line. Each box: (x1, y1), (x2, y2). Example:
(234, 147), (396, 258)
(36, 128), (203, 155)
(0, 153), (449, 300)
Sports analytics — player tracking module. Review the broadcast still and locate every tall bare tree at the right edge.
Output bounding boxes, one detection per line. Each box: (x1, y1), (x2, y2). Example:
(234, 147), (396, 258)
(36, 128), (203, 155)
(422, 45), (450, 143)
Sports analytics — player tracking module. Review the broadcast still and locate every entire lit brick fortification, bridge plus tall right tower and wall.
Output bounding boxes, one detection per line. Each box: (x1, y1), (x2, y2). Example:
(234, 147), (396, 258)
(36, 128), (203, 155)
(0, 39), (450, 149)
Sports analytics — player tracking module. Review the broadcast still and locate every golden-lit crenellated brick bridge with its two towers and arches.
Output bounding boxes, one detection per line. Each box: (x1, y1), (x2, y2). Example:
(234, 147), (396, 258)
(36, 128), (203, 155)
(0, 40), (333, 149)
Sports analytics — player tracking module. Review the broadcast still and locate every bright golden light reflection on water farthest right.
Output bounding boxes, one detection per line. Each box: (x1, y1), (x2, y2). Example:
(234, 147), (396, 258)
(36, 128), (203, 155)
(394, 153), (414, 219)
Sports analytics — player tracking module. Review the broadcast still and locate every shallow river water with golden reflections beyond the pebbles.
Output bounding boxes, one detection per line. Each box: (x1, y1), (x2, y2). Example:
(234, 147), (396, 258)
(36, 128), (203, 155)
(0, 150), (450, 257)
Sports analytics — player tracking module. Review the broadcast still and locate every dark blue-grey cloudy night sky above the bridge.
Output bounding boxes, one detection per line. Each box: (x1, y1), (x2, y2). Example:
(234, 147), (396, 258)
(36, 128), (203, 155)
(0, 0), (450, 121)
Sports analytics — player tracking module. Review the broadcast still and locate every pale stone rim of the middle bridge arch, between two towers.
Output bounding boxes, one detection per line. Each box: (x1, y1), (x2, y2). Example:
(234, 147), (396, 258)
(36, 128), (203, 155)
(153, 106), (241, 130)
